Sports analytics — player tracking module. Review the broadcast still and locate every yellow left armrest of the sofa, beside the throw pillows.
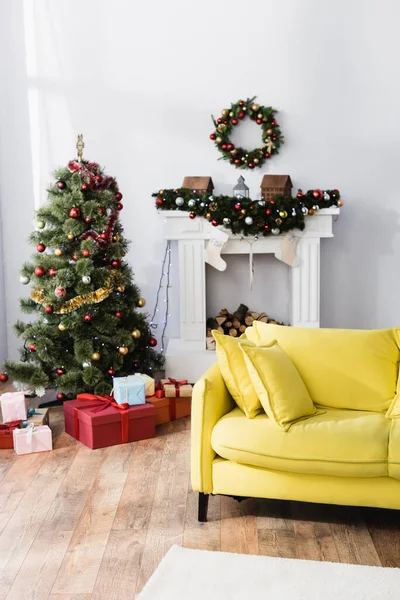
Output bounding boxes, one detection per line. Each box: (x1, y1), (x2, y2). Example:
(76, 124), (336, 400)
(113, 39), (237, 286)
(191, 363), (235, 494)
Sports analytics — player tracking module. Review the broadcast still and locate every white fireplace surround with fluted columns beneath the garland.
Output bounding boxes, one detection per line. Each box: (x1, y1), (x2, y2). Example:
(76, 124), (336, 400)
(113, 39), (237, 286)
(160, 207), (340, 382)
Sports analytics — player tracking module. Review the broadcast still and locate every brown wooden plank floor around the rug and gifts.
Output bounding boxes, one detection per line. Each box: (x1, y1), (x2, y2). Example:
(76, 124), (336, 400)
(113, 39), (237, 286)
(0, 408), (400, 600)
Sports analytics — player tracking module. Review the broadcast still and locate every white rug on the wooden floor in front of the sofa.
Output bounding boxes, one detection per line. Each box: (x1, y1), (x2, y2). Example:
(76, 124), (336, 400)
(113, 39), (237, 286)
(139, 546), (400, 600)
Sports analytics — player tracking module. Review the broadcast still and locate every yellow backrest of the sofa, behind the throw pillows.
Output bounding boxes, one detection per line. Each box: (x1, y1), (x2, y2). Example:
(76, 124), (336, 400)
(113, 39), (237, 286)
(246, 321), (400, 412)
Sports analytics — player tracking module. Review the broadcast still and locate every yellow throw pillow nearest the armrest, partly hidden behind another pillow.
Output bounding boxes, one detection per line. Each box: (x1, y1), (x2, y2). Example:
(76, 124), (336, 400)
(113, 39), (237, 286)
(212, 330), (262, 419)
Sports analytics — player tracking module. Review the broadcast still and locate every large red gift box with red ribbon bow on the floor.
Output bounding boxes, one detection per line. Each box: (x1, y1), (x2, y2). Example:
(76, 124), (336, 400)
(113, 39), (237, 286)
(64, 394), (156, 449)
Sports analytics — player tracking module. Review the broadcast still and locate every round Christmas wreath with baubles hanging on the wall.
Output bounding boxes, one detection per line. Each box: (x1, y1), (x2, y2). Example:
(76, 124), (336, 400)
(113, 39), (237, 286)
(210, 96), (283, 169)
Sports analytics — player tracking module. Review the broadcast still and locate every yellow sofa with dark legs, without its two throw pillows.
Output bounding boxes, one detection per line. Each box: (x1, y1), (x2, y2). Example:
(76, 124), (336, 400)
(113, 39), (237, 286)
(191, 323), (400, 521)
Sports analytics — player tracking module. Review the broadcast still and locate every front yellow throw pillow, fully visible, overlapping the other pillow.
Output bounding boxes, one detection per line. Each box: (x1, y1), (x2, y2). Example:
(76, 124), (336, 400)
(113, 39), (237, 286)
(239, 340), (316, 431)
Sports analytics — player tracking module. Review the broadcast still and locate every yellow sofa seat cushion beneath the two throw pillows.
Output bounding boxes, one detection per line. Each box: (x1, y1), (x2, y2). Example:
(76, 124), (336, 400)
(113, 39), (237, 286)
(211, 408), (390, 477)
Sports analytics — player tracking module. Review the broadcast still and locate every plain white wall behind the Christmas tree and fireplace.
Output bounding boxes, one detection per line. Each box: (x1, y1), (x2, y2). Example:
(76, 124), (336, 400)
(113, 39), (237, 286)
(0, 0), (400, 354)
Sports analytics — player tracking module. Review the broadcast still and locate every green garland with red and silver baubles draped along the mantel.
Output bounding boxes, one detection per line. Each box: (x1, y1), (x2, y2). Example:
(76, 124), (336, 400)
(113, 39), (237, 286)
(152, 188), (344, 236)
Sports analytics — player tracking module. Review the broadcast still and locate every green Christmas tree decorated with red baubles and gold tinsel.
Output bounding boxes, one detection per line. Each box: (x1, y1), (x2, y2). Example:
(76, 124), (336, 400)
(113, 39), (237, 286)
(3, 136), (162, 401)
